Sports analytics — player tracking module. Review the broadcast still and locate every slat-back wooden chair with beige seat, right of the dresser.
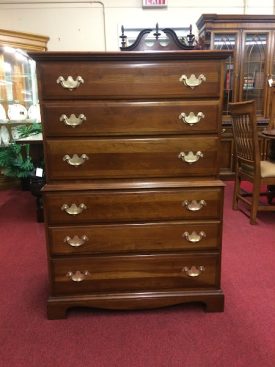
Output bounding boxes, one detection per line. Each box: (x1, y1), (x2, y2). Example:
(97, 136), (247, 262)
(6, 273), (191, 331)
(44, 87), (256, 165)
(229, 101), (275, 224)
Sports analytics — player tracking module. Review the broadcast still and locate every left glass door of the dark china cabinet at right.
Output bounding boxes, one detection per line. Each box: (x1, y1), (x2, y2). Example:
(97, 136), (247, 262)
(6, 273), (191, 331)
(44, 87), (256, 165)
(211, 32), (240, 115)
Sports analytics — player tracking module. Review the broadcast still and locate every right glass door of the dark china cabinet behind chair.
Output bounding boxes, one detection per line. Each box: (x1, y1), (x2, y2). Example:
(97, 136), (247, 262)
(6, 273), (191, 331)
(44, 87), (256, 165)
(242, 32), (270, 117)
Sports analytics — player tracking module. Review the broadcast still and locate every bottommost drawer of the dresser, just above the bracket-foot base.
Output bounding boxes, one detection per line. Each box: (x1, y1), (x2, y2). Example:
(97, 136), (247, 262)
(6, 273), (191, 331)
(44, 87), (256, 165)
(51, 254), (220, 295)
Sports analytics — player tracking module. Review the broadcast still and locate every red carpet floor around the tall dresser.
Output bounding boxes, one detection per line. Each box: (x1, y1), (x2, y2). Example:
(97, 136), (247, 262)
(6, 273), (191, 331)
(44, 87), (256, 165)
(0, 183), (275, 367)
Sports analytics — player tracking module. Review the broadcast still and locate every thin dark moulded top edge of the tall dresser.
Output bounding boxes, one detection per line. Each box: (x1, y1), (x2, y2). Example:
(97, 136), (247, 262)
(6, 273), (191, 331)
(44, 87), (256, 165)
(29, 50), (232, 61)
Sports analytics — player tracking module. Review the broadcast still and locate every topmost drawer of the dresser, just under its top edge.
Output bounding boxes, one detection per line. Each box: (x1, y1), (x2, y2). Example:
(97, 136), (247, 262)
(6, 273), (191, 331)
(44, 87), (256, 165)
(38, 60), (221, 99)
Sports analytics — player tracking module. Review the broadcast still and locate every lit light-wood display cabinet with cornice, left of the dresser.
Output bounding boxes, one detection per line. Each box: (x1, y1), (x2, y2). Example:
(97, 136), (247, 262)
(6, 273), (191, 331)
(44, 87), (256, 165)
(0, 29), (49, 188)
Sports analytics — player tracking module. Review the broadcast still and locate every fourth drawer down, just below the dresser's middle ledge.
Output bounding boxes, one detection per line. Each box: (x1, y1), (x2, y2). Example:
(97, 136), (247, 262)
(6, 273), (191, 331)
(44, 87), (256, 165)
(44, 188), (223, 225)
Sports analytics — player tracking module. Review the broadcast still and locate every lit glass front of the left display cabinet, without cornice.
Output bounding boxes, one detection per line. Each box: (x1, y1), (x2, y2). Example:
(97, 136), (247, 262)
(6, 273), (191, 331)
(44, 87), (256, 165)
(0, 46), (41, 146)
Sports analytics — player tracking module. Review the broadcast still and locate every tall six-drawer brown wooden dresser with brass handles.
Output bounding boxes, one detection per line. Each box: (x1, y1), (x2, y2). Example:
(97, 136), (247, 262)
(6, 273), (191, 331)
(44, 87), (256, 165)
(31, 50), (232, 319)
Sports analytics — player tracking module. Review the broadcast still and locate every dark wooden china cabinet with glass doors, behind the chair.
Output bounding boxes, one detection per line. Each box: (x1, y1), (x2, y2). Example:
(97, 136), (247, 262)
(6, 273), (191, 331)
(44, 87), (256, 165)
(197, 14), (275, 179)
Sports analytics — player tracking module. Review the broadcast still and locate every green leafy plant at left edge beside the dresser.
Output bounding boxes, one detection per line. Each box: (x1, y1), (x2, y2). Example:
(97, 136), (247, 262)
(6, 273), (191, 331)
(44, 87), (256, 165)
(0, 143), (34, 178)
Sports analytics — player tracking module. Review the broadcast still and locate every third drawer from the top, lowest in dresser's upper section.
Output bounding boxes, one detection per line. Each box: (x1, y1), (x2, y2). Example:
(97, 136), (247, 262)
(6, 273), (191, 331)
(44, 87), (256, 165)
(45, 136), (219, 180)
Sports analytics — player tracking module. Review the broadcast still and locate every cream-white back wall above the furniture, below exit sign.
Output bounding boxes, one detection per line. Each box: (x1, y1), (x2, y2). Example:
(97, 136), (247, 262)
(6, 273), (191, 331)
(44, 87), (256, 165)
(0, 0), (275, 51)
